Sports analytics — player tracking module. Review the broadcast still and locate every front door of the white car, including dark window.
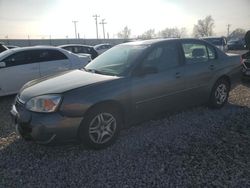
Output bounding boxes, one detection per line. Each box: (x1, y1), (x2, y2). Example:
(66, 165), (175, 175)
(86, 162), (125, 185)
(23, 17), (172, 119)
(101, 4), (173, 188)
(0, 50), (39, 95)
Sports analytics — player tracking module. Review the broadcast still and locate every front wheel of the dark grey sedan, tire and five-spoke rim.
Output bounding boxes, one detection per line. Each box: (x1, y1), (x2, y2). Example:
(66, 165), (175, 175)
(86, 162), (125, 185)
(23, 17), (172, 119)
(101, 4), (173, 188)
(79, 106), (122, 149)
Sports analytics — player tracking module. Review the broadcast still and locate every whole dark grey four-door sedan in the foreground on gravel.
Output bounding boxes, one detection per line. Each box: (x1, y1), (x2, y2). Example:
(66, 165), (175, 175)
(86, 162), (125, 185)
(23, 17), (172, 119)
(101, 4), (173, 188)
(11, 39), (241, 149)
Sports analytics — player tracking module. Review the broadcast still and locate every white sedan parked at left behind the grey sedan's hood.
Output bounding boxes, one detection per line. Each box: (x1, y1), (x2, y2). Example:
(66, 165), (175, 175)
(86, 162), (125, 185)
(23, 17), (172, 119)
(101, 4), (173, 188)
(0, 46), (91, 96)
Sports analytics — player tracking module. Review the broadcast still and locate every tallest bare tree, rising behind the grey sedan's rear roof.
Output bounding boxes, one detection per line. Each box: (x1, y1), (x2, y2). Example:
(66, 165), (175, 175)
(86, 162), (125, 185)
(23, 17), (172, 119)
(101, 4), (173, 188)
(193, 16), (214, 37)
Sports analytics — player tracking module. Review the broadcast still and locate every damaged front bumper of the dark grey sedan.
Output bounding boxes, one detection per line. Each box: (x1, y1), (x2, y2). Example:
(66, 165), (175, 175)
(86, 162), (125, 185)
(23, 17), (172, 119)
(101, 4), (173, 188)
(10, 100), (83, 144)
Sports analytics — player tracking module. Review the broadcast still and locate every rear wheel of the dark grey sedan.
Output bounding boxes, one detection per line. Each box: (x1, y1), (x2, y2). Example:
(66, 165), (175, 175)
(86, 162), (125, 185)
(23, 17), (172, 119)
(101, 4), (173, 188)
(209, 79), (230, 109)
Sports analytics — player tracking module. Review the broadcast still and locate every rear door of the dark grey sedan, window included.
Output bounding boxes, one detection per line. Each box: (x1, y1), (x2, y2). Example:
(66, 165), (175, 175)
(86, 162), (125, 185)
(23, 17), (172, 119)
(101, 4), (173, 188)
(182, 40), (217, 104)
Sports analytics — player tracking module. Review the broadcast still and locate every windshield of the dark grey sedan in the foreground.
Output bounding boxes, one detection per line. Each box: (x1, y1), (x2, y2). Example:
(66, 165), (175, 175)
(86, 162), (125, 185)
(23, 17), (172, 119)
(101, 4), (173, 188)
(85, 45), (147, 76)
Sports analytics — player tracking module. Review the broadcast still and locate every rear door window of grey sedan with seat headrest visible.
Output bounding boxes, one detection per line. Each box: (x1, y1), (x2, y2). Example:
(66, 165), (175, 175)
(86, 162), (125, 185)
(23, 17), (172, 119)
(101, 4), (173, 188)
(182, 43), (208, 64)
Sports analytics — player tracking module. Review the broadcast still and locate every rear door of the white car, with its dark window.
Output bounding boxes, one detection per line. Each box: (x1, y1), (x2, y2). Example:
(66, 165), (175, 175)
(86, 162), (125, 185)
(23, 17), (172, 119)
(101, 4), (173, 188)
(37, 49), (72, 76)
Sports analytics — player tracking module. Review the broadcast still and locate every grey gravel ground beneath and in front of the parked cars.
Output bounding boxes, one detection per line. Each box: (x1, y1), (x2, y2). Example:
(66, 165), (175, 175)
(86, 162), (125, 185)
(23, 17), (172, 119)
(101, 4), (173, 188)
(0, 83), (250, 187)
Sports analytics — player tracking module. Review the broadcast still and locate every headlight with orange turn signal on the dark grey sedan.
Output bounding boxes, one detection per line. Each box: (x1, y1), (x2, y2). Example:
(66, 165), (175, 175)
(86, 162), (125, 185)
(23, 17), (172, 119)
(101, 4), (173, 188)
(26, 95), (62, 113)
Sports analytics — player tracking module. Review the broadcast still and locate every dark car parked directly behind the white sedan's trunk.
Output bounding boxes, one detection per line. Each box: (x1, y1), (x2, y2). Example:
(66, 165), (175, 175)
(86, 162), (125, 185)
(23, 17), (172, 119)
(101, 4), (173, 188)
(58, 44), (98, 59)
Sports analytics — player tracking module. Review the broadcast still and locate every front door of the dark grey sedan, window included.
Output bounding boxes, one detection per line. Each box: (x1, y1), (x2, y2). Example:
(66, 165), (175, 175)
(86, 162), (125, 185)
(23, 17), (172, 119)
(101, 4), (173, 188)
(132, 41), (185, 117)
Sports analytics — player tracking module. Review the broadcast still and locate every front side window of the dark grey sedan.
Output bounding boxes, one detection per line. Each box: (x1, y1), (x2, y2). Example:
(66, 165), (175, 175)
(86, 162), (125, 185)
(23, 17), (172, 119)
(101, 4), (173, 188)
(143, 43), (179, 72)
